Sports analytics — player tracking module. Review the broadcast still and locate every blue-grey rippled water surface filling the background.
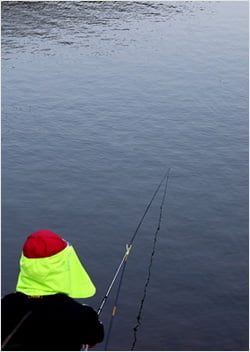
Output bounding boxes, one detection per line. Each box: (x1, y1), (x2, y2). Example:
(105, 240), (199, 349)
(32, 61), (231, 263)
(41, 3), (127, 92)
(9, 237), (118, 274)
(2, 1), (249, 351)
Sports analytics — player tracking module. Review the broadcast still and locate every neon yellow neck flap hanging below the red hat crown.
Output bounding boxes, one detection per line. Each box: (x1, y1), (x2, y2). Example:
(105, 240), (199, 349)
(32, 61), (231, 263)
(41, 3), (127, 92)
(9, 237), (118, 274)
(16, 245), (96, 298)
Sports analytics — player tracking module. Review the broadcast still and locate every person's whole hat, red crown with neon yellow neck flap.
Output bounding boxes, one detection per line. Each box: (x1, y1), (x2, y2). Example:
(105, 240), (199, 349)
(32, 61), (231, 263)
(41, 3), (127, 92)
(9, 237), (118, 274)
(16, 230), (95, 298)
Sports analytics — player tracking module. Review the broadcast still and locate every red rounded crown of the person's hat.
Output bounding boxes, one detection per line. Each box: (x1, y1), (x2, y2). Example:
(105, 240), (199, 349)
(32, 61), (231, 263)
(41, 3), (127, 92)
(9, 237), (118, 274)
(23, 230), (67, 258)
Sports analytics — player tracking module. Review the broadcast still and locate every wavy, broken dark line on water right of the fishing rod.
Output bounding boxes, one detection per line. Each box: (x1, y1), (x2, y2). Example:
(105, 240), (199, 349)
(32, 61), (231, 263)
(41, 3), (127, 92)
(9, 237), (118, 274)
(131, 169), (169, 351)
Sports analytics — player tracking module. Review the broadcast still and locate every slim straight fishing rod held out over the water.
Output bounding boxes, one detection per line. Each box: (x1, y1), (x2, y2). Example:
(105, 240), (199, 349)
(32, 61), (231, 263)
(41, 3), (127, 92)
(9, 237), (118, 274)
(97, 168), (170, 315)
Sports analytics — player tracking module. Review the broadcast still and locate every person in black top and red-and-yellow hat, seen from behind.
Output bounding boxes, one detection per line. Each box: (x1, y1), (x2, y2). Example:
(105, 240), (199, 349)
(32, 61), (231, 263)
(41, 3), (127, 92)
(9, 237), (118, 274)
(1, 230), (104, 351)
